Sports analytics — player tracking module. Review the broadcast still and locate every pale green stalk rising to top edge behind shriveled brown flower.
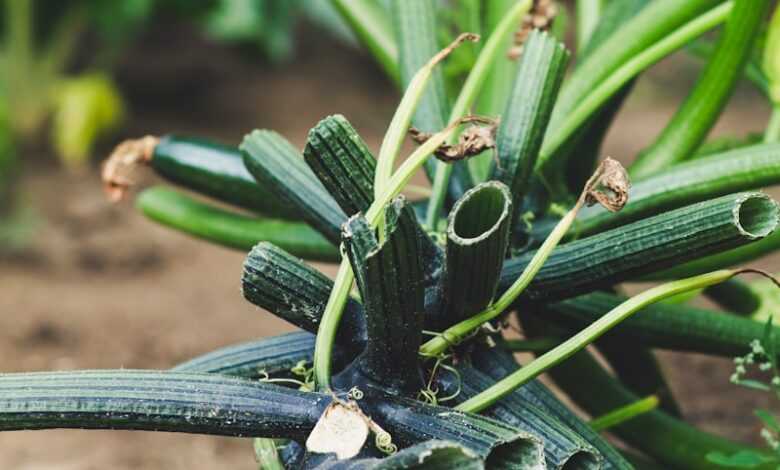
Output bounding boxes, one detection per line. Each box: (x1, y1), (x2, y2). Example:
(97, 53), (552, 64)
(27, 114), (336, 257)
(425, 0), (532, 229)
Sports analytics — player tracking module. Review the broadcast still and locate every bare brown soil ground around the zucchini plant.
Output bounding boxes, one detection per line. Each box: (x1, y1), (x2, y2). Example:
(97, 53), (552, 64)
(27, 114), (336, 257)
(0, 20), (778, 470)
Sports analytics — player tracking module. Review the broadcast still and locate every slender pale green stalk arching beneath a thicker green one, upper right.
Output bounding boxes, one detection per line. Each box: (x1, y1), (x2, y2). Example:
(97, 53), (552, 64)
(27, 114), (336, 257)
(537, 2), (733, 180)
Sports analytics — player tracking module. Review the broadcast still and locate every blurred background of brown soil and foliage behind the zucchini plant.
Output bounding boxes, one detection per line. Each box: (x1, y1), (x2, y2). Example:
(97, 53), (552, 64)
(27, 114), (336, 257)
(0, 0), (778, 470)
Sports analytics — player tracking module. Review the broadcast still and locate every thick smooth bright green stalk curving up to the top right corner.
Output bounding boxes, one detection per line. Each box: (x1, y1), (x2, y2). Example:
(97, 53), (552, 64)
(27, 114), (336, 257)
(631, 0), (771, 177)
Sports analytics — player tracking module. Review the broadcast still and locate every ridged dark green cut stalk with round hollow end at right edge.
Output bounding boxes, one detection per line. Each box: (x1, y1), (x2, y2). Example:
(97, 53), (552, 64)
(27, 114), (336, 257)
(499, 193), (778, 300)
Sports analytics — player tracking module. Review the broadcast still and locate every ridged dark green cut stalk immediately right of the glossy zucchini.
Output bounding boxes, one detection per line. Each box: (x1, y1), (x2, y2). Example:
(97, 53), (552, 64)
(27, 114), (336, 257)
(239, 130), (347, 245)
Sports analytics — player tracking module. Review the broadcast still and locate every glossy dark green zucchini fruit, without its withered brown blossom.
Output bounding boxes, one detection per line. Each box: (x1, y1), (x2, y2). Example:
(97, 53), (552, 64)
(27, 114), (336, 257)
(151, 135), (301, 220)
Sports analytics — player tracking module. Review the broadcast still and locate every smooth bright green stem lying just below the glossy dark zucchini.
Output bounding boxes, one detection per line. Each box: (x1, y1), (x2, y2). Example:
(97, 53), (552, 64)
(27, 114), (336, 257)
(136, 186), (339, 261)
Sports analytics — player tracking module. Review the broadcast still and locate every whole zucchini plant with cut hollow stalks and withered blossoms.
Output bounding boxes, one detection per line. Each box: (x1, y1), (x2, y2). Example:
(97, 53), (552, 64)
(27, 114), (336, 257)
(7, 0), (780, 469)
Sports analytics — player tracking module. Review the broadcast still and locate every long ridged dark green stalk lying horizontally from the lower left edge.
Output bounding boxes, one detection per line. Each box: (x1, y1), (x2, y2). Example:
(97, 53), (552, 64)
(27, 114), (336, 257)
(0, 369), (331, 439)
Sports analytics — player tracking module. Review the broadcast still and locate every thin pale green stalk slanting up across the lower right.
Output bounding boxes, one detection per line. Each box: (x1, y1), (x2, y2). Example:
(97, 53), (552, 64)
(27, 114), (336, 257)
(456, 269), (740, 413)
